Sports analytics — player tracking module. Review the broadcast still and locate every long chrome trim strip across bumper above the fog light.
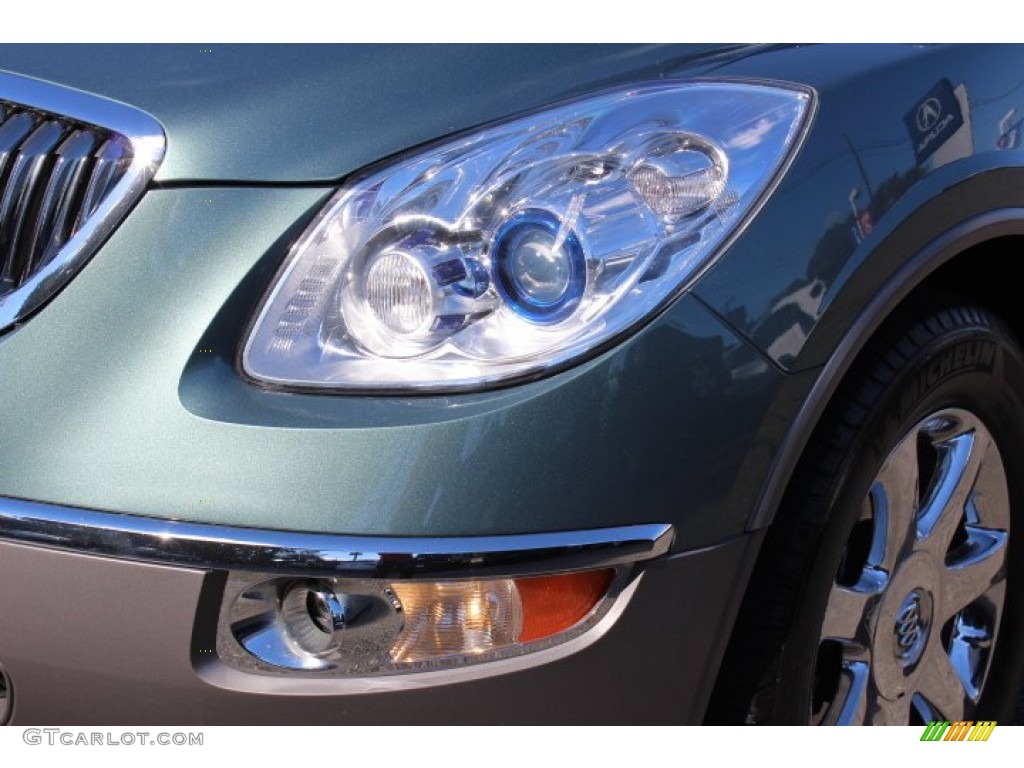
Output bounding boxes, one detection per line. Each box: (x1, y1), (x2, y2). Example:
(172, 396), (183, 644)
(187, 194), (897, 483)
(0, 497), (674, 579)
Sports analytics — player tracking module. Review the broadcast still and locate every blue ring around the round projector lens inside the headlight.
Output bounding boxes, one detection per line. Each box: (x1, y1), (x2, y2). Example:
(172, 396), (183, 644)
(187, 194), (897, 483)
(490, 209), (587, 325)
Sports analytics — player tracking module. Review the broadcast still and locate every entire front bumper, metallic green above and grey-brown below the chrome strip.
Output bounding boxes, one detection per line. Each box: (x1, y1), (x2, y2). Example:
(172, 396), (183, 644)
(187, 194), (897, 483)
(0, 188), (800, 724)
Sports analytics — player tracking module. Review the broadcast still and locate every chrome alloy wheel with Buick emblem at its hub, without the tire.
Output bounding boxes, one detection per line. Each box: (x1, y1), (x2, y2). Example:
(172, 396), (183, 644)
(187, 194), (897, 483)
(811, 409), (1010, 725)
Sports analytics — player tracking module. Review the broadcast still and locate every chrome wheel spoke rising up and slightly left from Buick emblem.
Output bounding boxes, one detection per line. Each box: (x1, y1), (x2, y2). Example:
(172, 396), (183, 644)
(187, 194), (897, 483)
(868, 435), (919, 573)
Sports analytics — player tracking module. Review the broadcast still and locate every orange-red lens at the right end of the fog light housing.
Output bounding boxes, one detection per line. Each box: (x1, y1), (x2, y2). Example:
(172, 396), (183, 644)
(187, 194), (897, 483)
(515, 569), (614, 643)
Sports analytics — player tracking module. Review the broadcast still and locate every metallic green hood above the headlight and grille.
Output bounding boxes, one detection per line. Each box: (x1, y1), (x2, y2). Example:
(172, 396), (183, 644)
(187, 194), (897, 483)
(0, 44), (750, 182)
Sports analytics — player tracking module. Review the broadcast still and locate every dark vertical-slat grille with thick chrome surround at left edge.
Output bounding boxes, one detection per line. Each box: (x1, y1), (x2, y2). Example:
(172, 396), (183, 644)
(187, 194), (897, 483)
(0, 73), (164, 330)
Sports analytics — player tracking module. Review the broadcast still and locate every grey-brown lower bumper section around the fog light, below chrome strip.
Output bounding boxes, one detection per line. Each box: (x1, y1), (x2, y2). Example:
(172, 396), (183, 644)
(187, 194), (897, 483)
(0, 501), (760, 725)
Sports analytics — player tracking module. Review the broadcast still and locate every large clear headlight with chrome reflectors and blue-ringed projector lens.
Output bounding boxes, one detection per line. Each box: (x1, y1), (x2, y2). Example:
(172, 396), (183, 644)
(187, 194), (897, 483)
(243, 82), (810, 389)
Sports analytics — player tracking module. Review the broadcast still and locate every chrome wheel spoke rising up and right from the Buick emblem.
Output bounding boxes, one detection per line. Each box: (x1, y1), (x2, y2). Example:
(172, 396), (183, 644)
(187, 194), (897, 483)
(918, 430), (990, 559)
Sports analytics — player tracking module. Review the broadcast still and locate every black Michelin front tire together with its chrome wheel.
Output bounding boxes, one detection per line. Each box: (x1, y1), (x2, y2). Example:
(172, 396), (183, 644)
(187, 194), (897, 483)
(709, 297), (1024, 725)
